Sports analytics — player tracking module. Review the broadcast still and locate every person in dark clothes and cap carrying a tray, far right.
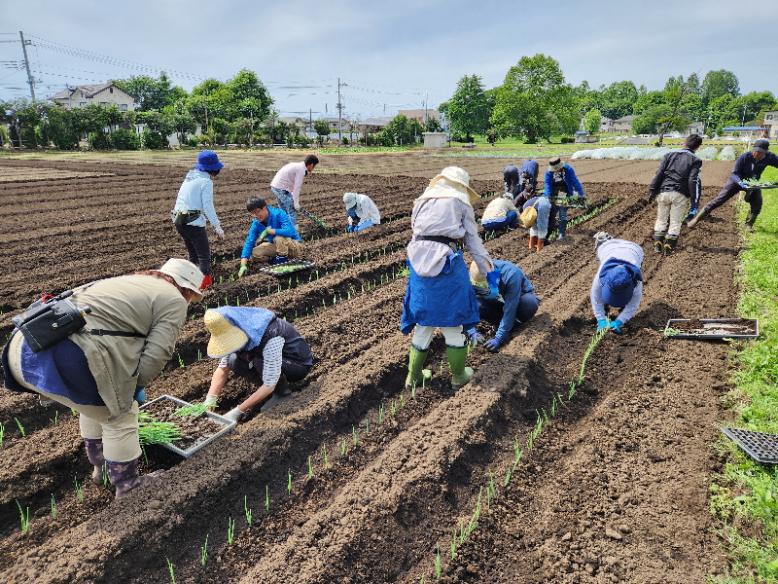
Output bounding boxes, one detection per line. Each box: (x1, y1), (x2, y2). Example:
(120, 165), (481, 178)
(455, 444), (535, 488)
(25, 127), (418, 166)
(688, 139), (778, 231)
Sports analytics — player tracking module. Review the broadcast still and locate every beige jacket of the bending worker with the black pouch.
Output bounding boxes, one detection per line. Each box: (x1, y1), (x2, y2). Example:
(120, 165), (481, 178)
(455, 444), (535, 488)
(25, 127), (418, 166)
(70, 275), (187, 416)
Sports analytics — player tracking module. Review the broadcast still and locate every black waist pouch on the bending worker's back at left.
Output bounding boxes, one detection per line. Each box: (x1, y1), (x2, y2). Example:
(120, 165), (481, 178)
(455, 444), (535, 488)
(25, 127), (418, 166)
(11, 290), (90, 353)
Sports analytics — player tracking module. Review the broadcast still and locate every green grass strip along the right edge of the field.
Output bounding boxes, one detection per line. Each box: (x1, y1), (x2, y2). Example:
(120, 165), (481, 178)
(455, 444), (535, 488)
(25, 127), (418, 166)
(710, 168), (778, 584)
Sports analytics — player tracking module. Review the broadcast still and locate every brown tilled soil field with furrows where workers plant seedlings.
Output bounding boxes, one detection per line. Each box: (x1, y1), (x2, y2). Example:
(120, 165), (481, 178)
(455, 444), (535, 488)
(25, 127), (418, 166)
(0, 152), (739, 584)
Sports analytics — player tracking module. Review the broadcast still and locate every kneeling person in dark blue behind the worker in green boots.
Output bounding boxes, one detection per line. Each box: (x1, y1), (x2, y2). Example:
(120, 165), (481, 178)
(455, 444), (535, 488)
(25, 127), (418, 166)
(467, 260), (540, 352)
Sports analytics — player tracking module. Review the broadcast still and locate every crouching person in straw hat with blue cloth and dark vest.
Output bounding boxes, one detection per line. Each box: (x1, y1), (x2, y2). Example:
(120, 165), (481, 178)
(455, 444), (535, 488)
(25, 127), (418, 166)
(204, 306), (313, 422)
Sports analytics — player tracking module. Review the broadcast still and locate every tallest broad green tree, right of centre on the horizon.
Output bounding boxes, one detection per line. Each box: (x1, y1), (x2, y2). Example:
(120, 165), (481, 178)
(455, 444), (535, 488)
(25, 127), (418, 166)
(491, 54), (578, 143)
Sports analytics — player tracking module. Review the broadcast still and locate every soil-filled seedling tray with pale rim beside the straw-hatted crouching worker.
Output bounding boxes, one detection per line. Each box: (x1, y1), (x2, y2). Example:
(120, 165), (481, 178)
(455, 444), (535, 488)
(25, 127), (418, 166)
(140, 395), (236, 458)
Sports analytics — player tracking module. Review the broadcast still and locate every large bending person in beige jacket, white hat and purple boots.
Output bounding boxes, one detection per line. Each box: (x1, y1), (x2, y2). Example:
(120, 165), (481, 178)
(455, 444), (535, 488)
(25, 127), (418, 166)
(3, 259), (203, 499)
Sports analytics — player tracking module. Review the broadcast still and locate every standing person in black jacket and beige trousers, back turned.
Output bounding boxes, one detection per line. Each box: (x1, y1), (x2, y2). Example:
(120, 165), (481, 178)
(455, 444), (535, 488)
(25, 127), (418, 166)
(648, 134), (702, 255)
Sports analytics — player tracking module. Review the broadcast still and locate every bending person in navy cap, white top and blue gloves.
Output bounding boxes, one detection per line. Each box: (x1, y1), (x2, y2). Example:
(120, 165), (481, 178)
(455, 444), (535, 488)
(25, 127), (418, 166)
(590, 231), (643, 334)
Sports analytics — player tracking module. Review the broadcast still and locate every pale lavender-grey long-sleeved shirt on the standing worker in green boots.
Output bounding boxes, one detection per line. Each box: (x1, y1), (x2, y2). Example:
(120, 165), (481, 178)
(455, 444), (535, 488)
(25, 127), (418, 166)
(408, 197), (491, 277)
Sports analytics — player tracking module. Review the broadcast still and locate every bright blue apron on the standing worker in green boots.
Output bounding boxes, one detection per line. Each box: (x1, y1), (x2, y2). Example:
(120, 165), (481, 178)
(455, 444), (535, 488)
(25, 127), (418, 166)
(400, 252), (480, 335)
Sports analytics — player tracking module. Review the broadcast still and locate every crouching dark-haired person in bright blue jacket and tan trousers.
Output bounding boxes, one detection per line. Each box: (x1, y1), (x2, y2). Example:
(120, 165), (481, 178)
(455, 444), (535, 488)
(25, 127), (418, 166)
(238, 197), (303, 278)
